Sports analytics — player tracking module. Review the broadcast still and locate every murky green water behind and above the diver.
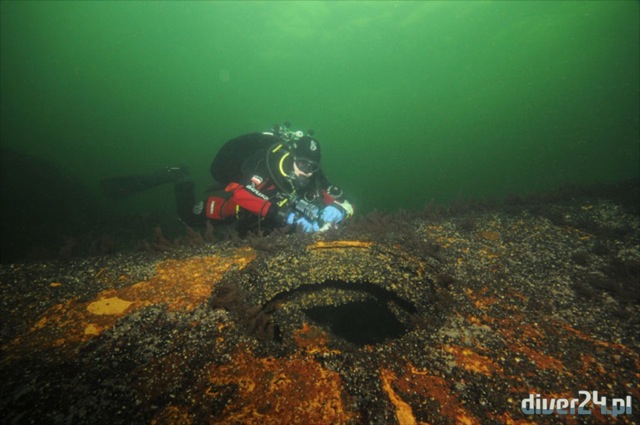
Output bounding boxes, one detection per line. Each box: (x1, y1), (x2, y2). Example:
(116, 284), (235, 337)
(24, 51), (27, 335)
(0, 1), (640, 212)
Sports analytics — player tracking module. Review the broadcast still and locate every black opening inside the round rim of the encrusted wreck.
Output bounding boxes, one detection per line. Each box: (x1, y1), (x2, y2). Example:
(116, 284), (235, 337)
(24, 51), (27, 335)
(304, 299), (406, 346)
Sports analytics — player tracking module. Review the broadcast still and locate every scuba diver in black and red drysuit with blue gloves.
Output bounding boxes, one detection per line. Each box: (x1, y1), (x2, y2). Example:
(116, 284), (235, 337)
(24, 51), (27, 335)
(176, 123), (353, 233)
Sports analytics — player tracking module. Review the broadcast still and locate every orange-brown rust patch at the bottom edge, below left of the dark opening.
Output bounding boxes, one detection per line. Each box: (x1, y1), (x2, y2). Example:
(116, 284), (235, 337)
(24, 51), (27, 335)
(205, 351), (354, 424)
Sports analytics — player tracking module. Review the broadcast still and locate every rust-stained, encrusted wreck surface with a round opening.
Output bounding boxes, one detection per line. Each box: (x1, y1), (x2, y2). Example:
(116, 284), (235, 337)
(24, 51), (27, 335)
(0, 186), (640, 424)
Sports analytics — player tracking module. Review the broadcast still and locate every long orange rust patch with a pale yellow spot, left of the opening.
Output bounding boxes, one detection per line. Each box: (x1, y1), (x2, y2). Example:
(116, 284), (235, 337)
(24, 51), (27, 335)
(2, 249), (255, 354)
